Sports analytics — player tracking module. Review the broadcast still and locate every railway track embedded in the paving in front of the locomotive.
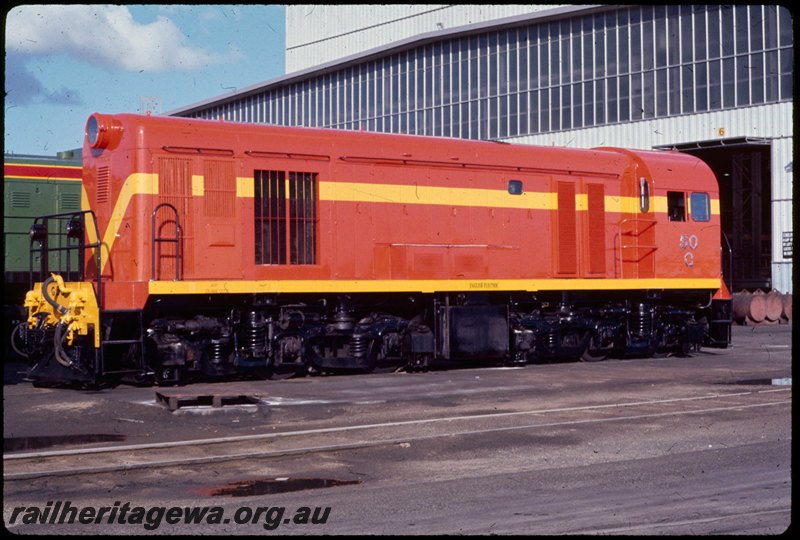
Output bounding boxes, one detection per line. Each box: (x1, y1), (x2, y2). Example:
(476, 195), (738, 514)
(3, 387), (792, 480)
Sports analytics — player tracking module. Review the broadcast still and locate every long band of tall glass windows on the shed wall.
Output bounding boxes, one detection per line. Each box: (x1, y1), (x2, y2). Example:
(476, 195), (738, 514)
(189, 5), (794, 139)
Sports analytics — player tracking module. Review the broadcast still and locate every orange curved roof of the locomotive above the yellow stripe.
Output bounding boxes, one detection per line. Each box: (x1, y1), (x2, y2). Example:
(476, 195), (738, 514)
(86, 114), (716, 189)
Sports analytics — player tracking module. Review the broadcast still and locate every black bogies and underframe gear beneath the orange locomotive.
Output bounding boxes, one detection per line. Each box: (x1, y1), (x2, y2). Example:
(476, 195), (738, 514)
(20, 295), (707, 385)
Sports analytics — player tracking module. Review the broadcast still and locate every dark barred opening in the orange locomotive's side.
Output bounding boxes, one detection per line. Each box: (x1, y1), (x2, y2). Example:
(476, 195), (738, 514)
(254, 171), (317, 264)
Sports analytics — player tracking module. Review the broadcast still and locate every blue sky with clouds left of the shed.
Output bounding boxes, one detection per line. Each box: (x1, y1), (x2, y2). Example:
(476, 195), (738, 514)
(3, 4), (285, 156)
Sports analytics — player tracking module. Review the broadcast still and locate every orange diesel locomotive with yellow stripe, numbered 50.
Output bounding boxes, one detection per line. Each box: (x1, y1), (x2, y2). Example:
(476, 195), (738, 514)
(17, 114), (730, 383)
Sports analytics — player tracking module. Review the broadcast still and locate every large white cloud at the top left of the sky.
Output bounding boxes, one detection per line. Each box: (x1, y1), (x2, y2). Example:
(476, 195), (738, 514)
(6, 5), (225, 71)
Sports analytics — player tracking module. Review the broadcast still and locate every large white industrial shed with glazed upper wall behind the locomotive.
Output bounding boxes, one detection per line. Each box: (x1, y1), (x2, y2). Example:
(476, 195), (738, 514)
(167, 4), (793, 293)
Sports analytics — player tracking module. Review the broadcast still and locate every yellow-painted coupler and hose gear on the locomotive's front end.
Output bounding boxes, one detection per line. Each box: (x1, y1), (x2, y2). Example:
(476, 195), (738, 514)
(25, 274), (100, 348)
